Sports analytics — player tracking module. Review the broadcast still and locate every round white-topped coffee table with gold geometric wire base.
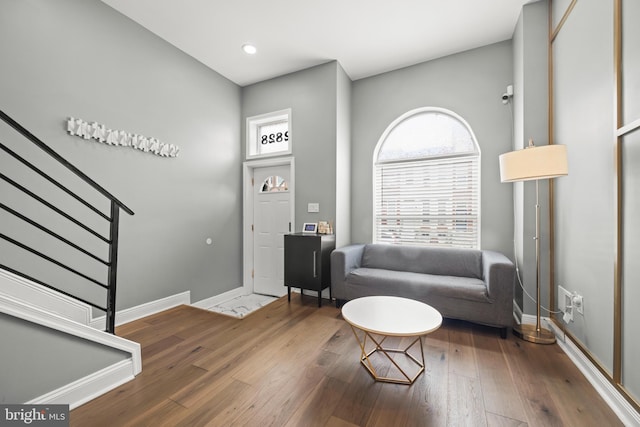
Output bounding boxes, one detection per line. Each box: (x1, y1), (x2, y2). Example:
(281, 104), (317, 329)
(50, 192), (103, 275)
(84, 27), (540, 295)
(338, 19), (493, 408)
(342, 296), (442, 385)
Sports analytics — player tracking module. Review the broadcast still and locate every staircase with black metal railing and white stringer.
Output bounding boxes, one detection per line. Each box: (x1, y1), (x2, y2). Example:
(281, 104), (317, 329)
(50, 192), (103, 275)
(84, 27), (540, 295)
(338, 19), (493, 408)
(0, 111), (141, 407)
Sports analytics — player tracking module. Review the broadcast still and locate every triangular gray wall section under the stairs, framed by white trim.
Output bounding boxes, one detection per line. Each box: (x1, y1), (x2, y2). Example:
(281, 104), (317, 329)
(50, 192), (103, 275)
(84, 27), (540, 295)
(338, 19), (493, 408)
(0, 313), (129, 403)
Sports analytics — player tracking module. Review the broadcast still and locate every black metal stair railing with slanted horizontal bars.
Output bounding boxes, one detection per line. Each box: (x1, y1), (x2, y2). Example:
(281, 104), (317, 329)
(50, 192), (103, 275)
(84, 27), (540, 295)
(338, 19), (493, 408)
(0, 111), (133, 333)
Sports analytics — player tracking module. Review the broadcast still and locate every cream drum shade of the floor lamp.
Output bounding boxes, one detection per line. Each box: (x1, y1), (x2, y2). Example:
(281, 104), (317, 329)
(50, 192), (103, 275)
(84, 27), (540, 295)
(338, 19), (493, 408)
(500, 144), (569, 182)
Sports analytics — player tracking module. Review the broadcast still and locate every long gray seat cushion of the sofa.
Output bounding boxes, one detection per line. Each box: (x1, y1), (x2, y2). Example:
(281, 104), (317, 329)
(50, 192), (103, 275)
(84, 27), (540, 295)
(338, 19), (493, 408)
(346, 268), (491, 304)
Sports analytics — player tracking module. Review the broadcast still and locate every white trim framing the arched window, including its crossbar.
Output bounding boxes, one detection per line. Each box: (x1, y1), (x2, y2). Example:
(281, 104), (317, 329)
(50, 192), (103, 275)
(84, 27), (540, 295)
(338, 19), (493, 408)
(371, 107), (482, 249)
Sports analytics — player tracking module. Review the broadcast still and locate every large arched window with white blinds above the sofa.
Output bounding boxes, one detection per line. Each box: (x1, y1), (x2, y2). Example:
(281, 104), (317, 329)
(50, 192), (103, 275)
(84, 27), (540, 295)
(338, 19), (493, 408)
(373, 107), (480, 248)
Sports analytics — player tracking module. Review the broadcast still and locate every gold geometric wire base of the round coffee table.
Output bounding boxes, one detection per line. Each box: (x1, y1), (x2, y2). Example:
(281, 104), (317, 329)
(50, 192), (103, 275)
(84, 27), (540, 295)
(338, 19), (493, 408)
(350, 325), (424, 385)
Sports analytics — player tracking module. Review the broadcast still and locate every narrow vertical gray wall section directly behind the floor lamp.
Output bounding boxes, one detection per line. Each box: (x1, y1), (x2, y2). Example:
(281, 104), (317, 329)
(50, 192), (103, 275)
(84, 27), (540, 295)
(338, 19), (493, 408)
(510, 1), (549, 316)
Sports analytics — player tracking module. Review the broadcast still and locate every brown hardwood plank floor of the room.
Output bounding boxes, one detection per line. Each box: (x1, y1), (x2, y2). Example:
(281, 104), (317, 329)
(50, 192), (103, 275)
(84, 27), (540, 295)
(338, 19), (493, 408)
(70, 295), (622, 427)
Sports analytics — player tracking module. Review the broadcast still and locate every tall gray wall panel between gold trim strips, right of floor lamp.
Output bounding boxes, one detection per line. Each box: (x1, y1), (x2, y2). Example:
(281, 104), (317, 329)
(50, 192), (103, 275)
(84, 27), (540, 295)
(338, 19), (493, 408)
(553, 0), (615, 370)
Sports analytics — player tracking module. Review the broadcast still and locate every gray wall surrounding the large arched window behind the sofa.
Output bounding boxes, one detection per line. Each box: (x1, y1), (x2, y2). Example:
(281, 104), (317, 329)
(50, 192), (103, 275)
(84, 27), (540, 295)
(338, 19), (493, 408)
(351, 40), (513, 256)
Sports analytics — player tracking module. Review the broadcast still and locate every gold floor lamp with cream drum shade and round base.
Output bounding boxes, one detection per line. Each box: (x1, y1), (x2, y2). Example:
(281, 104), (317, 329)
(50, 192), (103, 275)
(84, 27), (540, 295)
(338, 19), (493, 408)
(500, 139), (568, 344)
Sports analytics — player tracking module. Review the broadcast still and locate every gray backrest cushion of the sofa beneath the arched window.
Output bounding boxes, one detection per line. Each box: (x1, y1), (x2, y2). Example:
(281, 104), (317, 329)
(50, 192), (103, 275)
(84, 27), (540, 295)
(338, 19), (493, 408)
(361, 243), (482, 279)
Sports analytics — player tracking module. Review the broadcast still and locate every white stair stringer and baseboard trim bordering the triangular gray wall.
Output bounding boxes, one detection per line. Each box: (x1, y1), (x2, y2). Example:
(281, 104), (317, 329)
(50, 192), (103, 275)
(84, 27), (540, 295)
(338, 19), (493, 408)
(0, 288), (142, 409)
